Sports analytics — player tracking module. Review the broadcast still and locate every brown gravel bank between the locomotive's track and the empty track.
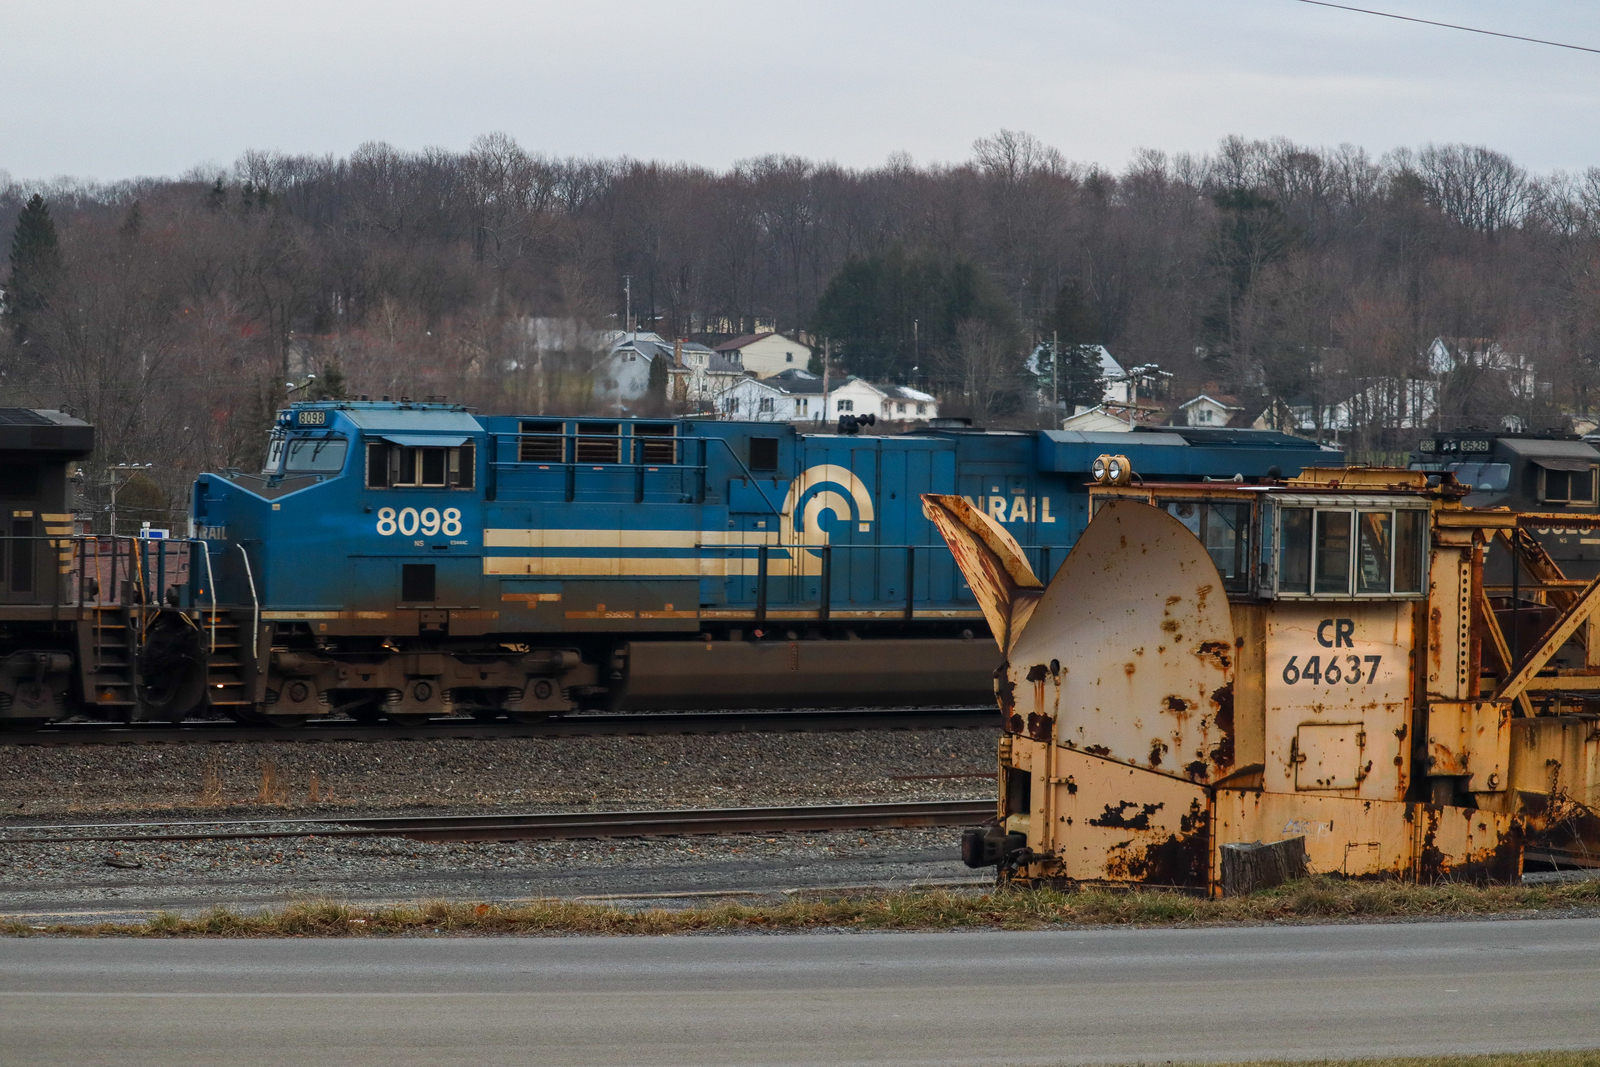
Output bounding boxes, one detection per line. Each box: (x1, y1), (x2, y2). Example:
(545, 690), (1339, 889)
(0, 729), (998, 824)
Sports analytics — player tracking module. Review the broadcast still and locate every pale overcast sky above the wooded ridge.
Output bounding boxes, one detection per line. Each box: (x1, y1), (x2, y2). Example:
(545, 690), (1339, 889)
(0, 0), (1600, 181)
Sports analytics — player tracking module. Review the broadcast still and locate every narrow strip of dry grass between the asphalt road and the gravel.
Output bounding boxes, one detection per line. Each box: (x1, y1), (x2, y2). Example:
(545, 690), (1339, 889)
(9, 878), (1600, 937)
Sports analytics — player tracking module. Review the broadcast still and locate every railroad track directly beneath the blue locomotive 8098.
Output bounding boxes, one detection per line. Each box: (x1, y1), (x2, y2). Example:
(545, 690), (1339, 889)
(0, 707), (998, 747)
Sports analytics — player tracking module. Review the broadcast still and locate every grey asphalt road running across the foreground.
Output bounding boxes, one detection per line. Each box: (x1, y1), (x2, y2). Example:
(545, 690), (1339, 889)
(0, 918), (1600, 1067)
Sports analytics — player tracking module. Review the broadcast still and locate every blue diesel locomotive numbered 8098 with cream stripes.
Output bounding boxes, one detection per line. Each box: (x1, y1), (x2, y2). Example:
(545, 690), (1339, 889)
(168, 402), (1342, 723)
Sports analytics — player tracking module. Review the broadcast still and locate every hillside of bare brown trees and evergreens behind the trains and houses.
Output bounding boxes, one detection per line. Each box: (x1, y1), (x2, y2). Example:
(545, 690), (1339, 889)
(0, 131), (1600, 508)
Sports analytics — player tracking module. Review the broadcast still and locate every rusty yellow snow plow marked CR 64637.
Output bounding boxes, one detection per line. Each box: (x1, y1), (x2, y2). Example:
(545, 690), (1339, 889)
(923, 467), (1600, 894)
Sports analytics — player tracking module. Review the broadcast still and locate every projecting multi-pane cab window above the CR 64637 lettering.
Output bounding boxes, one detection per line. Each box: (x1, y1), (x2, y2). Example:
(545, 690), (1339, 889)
(1277, 507), (1427, 598)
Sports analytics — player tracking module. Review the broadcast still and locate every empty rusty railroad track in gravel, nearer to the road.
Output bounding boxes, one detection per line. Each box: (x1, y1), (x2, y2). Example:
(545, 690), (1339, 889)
(0, 800), (995, 846)
